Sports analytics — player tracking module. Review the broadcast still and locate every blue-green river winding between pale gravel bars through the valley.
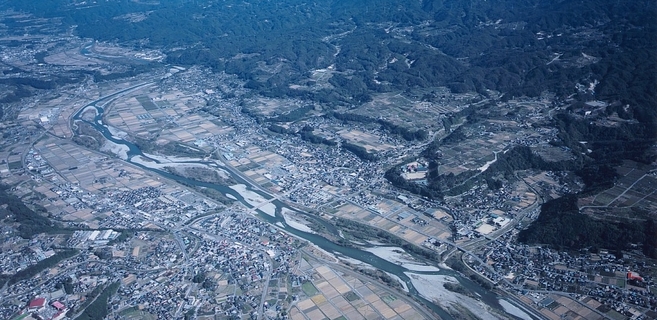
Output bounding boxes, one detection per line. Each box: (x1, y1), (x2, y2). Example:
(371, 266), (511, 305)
(72, 92), (540, 320)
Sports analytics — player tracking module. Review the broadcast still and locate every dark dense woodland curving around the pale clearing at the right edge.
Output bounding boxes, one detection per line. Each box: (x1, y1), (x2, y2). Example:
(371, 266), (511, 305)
(519, 115), (657, 252)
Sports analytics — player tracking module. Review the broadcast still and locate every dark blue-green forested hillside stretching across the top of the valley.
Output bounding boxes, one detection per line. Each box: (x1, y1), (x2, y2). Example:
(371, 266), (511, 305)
(4, 0), (657, 120)
